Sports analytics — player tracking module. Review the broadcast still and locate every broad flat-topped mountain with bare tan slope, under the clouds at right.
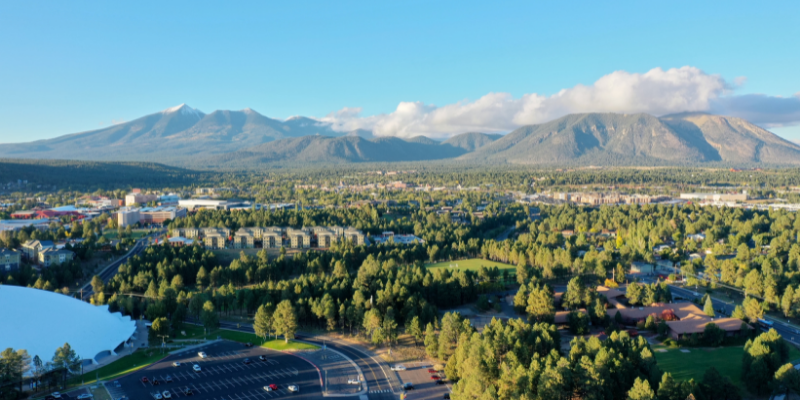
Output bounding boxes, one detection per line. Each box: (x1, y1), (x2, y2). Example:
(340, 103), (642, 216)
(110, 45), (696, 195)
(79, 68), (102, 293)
(461, 114), (800, 165)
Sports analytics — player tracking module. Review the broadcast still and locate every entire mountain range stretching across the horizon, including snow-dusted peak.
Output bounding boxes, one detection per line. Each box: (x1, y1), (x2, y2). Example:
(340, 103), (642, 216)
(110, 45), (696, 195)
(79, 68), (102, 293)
(0, 104), (800, 169)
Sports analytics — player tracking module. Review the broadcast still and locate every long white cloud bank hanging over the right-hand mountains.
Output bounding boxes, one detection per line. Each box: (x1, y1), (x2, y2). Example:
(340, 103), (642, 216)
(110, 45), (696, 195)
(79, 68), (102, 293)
(321, 66), (800, 138)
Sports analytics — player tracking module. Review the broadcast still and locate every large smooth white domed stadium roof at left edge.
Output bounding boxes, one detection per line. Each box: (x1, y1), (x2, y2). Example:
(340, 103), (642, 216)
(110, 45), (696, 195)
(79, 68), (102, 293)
(0, 285), (136, 363)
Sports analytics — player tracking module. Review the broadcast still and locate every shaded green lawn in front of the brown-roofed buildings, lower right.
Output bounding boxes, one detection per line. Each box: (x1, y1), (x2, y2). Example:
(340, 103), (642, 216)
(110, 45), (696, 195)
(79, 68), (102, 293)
(654, 346), (800, 386)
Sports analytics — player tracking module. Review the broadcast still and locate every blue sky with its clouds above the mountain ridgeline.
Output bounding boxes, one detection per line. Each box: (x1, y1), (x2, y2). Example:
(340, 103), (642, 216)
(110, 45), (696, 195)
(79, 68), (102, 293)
(0, 1), (800, 143)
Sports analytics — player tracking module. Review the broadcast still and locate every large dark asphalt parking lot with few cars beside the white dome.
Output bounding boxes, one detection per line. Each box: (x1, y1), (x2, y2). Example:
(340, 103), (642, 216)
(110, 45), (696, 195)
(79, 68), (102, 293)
(106, 341), (322, 400)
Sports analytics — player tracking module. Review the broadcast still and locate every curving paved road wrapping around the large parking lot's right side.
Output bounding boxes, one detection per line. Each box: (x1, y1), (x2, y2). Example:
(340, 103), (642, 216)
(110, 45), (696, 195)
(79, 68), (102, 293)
(203, 322), (400, 400)
